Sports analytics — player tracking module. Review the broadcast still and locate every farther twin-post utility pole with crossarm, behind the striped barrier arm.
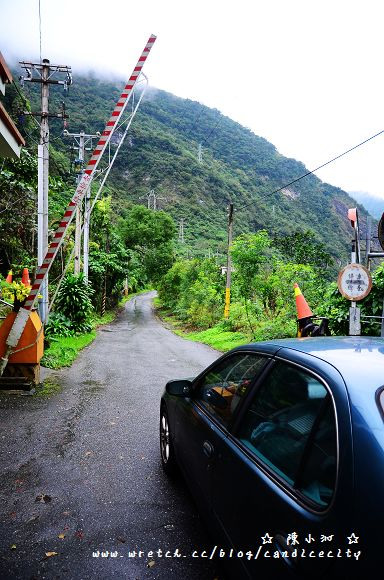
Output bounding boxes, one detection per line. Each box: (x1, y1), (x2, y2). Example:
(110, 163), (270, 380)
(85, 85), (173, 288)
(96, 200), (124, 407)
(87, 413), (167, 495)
(64, 131), (100, 281)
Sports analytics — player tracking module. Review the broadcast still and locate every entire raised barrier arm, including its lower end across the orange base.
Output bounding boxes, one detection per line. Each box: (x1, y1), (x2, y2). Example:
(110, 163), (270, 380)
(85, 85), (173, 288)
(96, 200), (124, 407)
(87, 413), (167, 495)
(0, 34), (156, 376)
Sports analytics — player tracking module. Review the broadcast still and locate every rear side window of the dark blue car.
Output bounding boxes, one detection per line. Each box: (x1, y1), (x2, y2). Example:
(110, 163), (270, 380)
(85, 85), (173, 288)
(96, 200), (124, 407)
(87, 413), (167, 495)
(237, 362), (336, 506)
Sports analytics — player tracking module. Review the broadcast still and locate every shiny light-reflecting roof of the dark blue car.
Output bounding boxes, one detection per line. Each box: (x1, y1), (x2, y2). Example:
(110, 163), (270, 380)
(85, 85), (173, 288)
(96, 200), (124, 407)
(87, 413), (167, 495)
(234, 336), (384, 398)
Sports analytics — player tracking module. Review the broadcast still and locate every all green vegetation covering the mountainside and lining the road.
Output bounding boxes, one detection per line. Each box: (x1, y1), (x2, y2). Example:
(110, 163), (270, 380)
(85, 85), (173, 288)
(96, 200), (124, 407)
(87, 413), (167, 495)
(0, 75), (383, 339)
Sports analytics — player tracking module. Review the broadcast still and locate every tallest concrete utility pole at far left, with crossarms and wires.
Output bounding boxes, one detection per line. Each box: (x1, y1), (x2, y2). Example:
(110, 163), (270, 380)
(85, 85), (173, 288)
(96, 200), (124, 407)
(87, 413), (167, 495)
(20, 58), (72, 323)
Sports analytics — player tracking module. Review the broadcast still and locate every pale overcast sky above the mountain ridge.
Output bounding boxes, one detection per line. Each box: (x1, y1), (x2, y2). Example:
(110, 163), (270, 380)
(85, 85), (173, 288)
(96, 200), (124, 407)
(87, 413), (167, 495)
(0, 0), (384, 198)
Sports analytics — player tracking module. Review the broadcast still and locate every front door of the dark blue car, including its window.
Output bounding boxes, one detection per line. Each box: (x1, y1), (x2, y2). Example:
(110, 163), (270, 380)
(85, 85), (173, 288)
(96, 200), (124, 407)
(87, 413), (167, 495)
(174, 351), (270, 511)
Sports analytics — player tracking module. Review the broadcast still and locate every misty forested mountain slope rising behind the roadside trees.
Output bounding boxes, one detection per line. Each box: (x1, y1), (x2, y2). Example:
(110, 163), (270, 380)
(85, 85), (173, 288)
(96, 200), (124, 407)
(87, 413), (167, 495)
(12, 75), (367, 261)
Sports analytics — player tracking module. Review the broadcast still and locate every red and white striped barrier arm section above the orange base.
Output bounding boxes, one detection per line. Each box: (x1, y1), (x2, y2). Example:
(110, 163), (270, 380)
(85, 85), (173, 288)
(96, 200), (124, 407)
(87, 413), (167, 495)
(24, 35), (156, 310)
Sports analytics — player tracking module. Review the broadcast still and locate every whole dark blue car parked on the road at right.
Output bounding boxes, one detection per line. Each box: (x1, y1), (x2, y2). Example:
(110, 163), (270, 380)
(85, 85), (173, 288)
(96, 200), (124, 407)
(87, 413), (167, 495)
(160, 337), (384, 580)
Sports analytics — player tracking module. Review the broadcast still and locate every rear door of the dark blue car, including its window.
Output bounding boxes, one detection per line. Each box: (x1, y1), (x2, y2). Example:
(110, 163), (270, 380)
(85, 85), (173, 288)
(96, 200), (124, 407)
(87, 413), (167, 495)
(211, 357), (353, 580)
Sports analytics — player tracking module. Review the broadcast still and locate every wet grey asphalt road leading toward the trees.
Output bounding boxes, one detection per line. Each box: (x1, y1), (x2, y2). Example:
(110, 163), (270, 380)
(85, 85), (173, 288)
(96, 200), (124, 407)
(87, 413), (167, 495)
(0, 293), (223, 580)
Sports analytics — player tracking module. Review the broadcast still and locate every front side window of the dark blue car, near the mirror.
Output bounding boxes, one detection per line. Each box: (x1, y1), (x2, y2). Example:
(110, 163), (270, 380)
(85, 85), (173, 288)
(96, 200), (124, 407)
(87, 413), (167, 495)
(194, 353), (269, 426)
